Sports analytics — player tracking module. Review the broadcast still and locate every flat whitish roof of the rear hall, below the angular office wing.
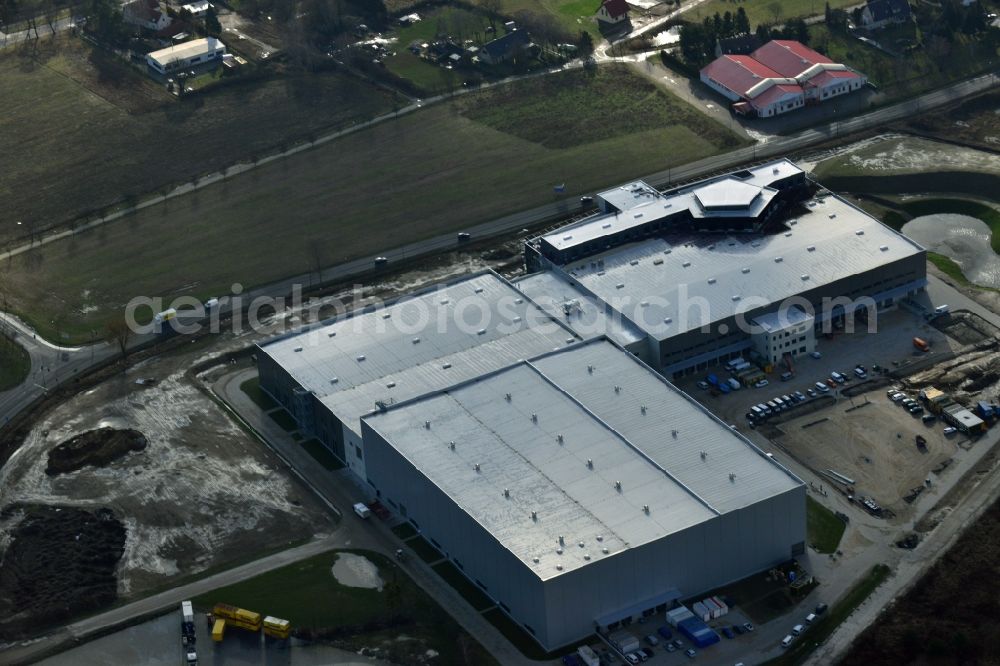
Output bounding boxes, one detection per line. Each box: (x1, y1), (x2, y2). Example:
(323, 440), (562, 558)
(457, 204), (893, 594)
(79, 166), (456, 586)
(562, 189), (923, 340)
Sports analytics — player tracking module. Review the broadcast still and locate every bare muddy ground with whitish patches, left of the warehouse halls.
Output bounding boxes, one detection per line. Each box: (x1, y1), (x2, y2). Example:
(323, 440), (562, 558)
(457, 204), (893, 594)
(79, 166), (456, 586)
(0, 345), (332, 630)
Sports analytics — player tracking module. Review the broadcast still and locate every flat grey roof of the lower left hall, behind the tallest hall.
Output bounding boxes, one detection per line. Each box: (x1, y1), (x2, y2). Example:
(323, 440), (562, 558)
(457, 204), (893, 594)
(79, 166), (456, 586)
(261, 272), (579, 433)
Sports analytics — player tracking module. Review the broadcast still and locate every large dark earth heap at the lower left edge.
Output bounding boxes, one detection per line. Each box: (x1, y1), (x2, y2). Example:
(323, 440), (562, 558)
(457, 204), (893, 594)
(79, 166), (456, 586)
(0, 506), (126, 638)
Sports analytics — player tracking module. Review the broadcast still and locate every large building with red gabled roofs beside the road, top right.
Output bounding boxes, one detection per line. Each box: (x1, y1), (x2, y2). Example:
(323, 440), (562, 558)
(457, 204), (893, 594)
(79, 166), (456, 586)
(701, 39), (868, 118)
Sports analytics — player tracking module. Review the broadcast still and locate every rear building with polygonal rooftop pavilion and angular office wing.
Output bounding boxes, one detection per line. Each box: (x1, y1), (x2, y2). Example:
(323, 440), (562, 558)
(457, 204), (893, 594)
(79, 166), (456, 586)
(517, 160), (927, 377)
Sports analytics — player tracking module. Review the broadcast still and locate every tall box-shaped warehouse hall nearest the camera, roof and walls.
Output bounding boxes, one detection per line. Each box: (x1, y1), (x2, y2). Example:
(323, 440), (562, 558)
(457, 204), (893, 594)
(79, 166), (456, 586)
(362, 338), (805, 649)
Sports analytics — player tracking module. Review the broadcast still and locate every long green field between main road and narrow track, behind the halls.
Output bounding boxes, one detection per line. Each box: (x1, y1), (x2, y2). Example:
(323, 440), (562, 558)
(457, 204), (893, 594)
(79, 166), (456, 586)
(5, 67), (742, 341)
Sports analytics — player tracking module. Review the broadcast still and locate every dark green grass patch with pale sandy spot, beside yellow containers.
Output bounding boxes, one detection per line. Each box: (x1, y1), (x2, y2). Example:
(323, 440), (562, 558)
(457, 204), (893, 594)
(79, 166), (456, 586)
(193, 551), (496, 666)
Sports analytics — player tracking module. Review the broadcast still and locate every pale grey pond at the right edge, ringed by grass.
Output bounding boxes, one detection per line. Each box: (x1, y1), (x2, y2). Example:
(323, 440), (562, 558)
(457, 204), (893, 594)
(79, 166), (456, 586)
(902, 214), (1000, 288)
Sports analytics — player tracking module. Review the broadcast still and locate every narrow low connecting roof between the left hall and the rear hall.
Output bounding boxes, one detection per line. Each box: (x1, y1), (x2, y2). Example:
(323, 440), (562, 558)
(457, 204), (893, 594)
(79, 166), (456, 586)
(514, 271), (646, 347)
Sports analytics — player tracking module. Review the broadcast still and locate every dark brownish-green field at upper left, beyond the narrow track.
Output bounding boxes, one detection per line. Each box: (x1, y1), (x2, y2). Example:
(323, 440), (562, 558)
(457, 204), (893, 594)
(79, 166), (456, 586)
(0, 36), (402, 243)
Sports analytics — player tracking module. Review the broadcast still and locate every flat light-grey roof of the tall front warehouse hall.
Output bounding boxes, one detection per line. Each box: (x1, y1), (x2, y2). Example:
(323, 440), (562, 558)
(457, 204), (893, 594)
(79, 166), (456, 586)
(364, 339), (802, 579)
